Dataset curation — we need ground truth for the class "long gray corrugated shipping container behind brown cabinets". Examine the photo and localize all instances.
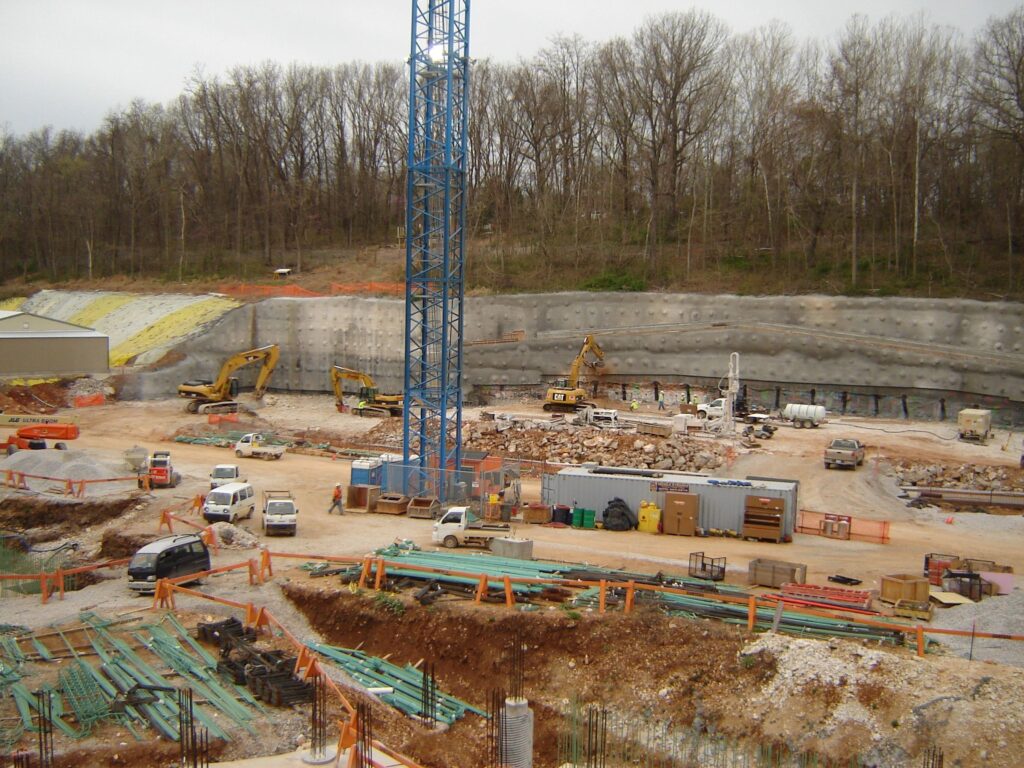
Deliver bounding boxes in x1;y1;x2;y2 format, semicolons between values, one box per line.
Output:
541;467;800;541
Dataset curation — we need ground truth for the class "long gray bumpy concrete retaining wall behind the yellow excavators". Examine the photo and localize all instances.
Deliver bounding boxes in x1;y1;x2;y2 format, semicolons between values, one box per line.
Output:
126;293;1024;421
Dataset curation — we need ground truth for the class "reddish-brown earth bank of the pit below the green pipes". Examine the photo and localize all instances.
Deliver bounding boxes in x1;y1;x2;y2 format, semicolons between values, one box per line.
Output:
284;583;798;768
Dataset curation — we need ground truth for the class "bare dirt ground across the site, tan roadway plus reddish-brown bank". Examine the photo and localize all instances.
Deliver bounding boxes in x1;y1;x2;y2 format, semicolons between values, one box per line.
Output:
0;394;1024;767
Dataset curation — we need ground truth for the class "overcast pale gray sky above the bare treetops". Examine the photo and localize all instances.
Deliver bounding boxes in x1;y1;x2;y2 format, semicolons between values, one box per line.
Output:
0;0;1020;134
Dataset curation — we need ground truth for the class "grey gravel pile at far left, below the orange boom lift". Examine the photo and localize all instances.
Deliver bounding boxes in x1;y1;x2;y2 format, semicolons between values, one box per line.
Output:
0;449;138;498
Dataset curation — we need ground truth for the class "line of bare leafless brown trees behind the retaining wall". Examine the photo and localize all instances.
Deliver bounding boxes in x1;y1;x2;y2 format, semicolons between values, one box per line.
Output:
0;7;1024;296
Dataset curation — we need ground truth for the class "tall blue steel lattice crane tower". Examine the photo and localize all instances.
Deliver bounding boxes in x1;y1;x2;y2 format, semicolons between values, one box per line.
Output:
402;0;469;502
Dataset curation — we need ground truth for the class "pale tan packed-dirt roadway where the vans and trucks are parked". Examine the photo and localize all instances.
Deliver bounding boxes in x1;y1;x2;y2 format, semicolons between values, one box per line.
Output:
54;395;1024;586
